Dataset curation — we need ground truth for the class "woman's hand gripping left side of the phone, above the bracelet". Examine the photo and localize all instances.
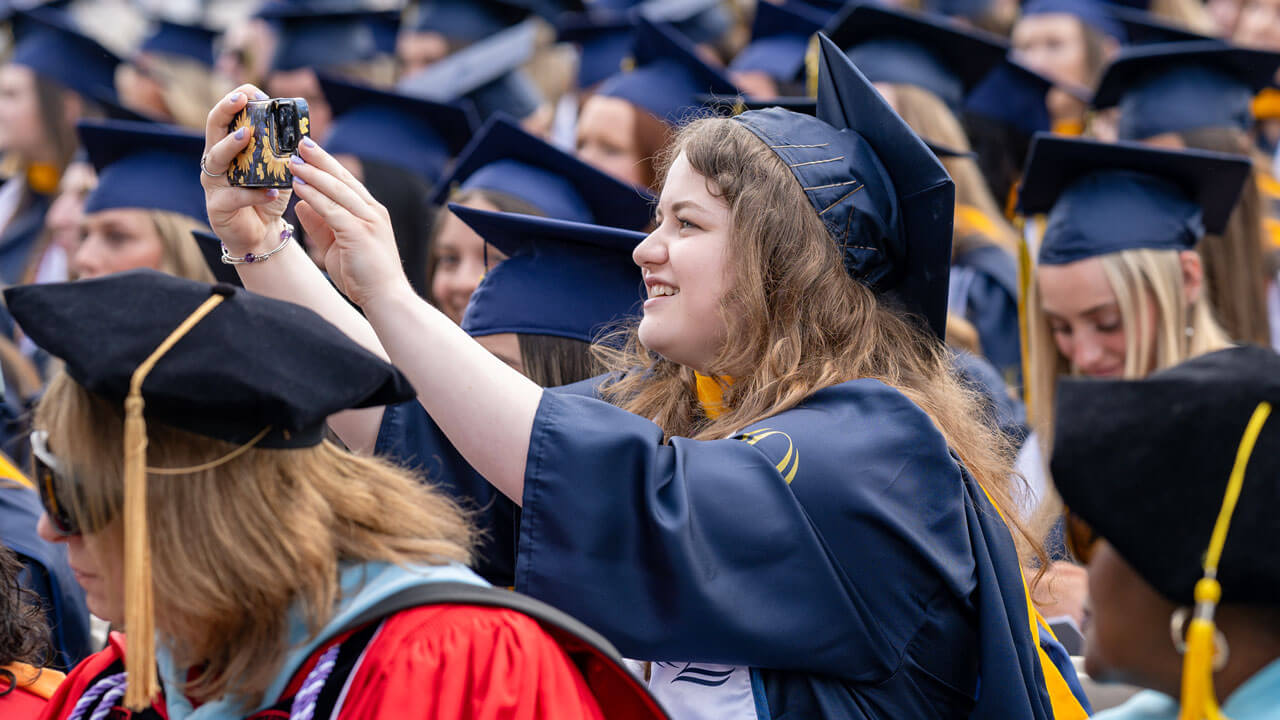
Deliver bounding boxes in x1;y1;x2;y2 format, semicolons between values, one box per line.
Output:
200;85;291;255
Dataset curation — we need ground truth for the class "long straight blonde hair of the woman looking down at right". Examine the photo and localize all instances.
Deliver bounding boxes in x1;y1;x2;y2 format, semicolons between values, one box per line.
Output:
1027;250;1230;537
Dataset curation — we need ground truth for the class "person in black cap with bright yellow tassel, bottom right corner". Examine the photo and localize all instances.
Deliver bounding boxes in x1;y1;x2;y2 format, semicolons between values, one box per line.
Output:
1052;347;1280;720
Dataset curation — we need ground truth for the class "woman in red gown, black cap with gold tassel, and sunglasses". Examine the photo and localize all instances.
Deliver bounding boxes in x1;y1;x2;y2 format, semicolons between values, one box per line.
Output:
20;270;662;720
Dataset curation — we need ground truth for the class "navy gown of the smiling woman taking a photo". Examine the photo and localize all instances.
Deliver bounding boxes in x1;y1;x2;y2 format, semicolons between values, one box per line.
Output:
516;379;1052;719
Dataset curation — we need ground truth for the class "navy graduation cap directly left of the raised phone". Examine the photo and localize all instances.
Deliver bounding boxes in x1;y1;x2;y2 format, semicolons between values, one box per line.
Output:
76;120;207;223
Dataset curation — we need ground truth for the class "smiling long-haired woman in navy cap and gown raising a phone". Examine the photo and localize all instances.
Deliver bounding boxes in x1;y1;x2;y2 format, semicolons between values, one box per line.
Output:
209;37;1085;720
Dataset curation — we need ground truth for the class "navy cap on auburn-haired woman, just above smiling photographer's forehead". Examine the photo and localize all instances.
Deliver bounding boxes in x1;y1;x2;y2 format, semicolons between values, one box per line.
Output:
596;18;737;124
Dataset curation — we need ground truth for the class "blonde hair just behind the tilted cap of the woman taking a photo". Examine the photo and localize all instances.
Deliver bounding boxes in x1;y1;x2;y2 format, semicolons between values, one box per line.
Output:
890;85;1019;256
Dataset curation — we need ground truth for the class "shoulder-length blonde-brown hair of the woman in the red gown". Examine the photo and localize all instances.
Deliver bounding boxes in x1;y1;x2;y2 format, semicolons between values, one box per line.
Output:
33;373;474;706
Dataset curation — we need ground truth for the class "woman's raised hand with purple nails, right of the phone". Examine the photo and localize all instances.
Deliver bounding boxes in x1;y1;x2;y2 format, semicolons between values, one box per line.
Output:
291;138;412;307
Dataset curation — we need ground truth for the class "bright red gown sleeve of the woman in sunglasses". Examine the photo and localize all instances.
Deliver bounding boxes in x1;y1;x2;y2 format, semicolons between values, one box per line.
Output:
339;605;603;720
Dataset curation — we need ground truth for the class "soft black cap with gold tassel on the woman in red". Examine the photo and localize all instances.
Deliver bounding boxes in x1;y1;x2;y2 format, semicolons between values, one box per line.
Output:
4;269;415;708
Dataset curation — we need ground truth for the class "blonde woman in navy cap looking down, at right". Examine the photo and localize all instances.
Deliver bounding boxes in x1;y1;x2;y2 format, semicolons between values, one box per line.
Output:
1018;135;1251;571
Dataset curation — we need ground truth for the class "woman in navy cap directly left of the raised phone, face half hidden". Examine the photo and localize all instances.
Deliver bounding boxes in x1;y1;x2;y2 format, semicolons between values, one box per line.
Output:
70;120;212;281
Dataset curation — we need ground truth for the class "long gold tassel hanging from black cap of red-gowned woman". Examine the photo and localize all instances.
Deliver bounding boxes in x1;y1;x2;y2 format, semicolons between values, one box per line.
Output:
124;295;225;712
